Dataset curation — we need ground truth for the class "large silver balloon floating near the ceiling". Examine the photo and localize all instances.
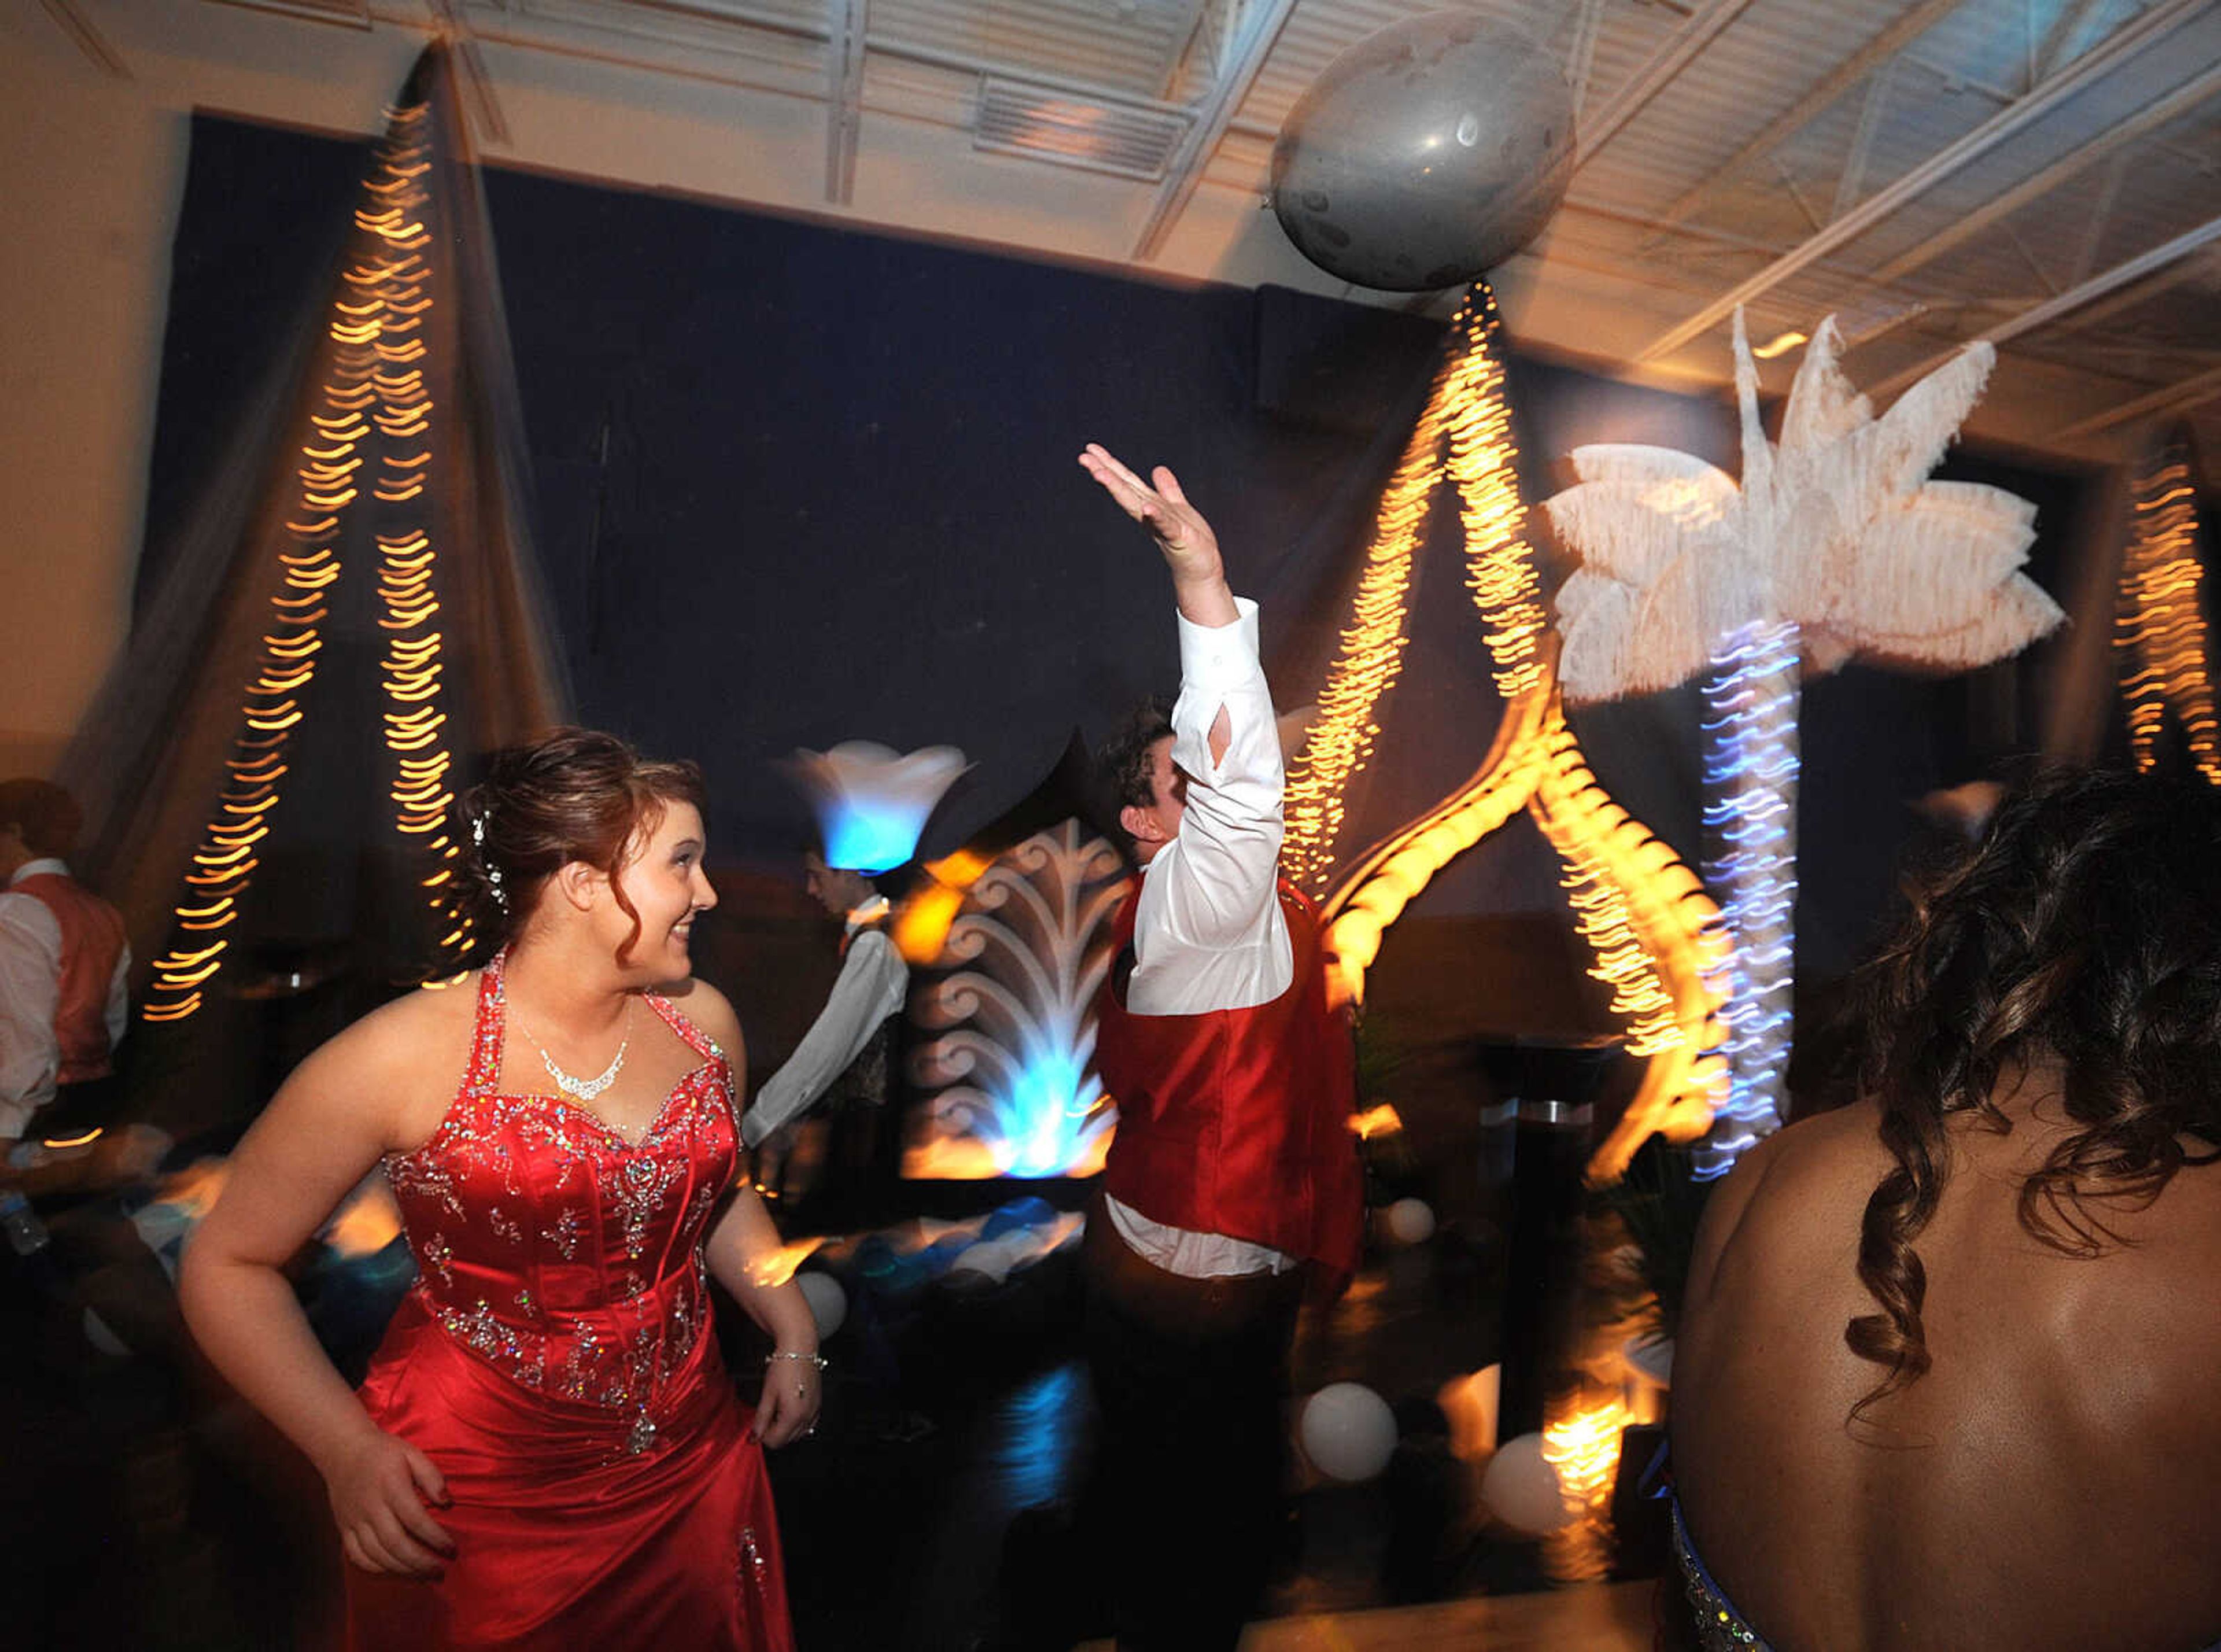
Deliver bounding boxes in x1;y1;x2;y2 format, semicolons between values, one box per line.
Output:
1272;11;1573;293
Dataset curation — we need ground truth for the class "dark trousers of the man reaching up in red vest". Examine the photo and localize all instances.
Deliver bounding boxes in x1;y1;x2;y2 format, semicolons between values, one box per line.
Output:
1084;1201;1301;1652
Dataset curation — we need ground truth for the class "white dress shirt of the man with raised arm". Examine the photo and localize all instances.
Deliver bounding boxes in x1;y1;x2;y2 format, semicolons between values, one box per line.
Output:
1104;598;1295;1279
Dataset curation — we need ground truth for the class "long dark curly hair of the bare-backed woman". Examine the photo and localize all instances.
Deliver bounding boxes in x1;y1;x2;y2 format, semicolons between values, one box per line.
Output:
1843;770;2221;1421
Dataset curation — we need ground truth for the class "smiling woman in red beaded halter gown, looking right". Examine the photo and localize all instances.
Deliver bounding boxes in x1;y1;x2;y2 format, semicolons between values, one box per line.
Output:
180;731;820;1652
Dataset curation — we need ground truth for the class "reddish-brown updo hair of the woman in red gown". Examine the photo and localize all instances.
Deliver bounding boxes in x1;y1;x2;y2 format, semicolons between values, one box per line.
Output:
455;728;706;964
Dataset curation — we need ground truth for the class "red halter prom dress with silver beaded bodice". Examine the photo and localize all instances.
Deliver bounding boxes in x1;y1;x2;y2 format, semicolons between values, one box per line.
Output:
349;959;793;1652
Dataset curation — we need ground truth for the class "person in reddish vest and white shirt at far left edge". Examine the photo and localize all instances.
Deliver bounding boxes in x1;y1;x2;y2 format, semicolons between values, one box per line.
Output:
0;779;131;1155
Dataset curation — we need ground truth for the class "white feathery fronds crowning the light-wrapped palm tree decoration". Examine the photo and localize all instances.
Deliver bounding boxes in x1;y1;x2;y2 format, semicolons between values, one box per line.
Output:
1544;315;2063;702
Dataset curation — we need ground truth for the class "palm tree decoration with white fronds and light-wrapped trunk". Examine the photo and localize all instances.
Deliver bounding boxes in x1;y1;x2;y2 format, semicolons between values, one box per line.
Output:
1544;311;2063;1175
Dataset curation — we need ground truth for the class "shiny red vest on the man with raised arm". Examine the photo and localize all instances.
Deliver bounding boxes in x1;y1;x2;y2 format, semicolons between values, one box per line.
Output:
1095;879;1364;1286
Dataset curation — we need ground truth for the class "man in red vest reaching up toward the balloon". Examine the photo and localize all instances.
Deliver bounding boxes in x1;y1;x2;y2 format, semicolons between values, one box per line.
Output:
1079;447;1364;1647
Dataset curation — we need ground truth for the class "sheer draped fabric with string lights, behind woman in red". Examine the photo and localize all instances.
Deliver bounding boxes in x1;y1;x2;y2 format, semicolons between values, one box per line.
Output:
56;45;569;990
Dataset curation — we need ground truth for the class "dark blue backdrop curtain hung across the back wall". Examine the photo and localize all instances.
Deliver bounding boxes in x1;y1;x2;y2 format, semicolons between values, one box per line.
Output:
142;116;2081;999
